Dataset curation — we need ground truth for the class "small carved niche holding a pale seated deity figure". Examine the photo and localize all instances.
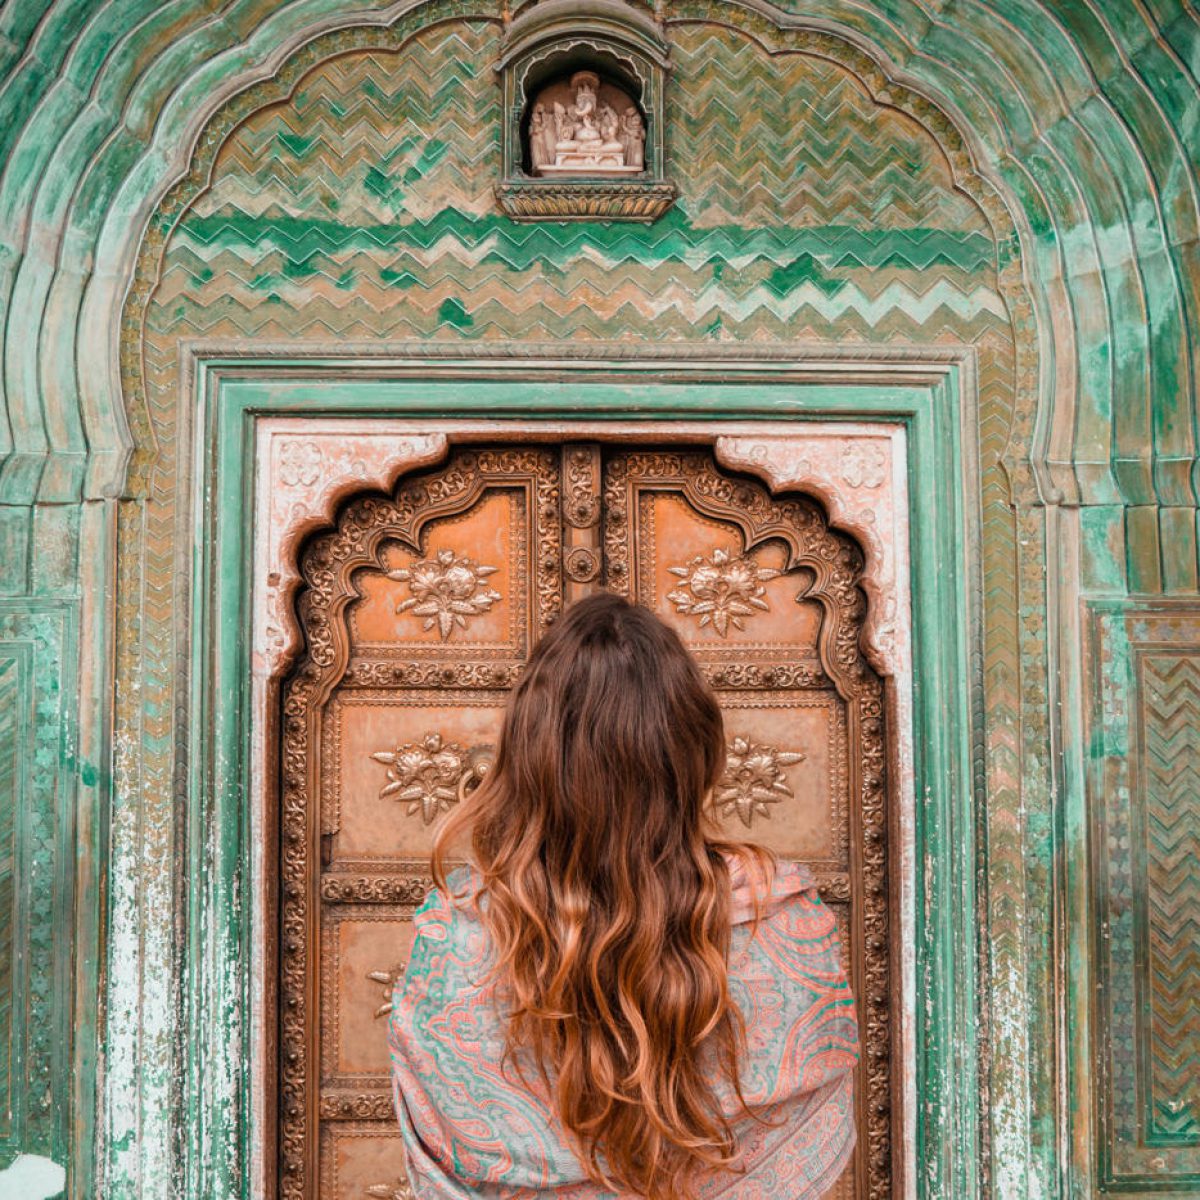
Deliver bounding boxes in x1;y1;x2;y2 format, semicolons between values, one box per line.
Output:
496;0;676;222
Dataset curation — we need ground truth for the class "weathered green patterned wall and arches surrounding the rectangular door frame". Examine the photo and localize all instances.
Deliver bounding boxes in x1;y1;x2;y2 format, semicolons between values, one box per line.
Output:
0;0;1200;1200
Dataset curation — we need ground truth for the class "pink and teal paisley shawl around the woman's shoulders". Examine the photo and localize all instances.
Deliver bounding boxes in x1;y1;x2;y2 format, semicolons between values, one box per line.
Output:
389;864;858;1200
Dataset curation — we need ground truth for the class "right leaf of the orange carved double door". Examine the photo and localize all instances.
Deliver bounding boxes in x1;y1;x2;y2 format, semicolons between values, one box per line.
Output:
604;450;890;1196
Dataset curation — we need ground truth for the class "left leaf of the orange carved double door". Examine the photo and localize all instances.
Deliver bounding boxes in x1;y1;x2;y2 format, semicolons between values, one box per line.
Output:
278;448;563;1200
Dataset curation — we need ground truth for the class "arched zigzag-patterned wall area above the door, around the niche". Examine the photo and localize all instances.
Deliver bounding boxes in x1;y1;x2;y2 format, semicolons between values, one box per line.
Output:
146;20;1010;357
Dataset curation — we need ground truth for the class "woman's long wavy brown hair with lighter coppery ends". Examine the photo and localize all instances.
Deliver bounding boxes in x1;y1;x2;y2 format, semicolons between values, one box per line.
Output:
433;594;772;1200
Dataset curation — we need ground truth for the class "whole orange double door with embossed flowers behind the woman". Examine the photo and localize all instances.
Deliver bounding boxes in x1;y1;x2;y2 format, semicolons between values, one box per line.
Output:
278;444;892;1200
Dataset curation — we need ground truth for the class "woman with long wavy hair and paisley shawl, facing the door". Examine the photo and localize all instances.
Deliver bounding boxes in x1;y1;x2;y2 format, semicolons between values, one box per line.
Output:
390;594;858;1200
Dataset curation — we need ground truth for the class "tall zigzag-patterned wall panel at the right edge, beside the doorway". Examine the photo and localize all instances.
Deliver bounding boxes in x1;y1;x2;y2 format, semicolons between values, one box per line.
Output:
1090;601;1200;1195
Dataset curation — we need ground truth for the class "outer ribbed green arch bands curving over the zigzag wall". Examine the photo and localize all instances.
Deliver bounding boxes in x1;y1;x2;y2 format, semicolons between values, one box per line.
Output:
0;0;1200;530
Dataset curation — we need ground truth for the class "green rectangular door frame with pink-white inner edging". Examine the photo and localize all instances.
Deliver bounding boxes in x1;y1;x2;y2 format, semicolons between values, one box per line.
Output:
185;343;986;1198
